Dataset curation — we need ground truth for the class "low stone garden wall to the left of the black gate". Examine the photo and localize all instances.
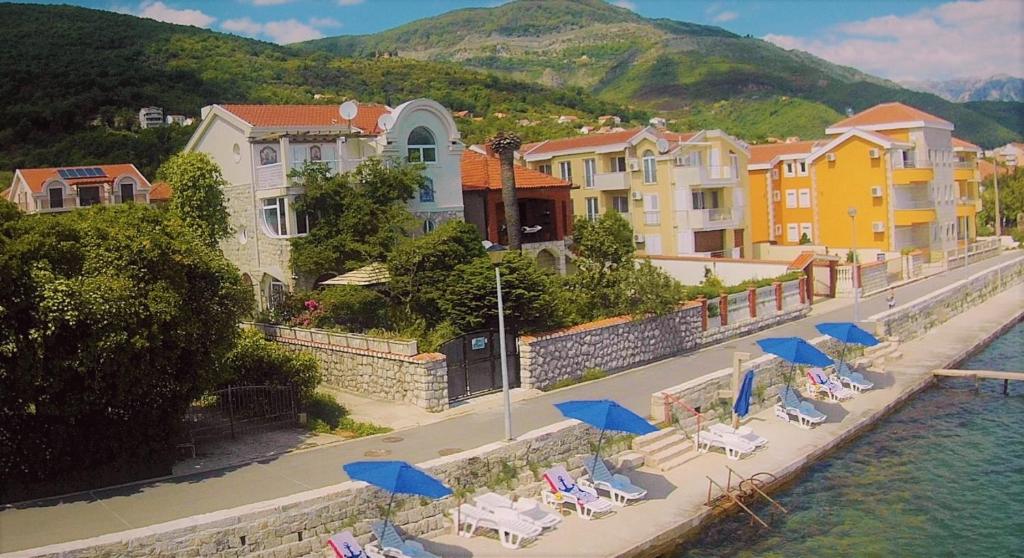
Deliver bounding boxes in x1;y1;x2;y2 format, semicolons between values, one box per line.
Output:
246;324;449;412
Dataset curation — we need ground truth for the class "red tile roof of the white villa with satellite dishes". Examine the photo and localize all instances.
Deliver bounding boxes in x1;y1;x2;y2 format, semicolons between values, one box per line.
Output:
221;103;391;135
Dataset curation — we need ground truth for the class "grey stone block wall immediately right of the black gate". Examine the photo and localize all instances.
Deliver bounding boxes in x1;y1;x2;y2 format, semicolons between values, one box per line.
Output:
519;303;700;389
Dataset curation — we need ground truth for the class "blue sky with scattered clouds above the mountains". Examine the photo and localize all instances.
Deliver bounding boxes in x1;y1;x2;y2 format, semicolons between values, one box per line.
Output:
16;0;1024;80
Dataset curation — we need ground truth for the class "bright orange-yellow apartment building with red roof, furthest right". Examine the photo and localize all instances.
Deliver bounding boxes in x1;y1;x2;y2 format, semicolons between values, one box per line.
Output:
748;102;979;252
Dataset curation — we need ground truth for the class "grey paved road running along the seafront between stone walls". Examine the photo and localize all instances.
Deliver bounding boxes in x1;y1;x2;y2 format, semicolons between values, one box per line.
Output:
0;251;1021;552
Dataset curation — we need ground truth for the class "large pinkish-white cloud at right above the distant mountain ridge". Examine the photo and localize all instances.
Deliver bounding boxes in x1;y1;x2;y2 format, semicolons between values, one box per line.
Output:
764;0;1024;80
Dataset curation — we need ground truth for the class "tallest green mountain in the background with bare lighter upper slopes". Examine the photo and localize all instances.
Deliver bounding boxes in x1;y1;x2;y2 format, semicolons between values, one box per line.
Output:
295;0;1024;146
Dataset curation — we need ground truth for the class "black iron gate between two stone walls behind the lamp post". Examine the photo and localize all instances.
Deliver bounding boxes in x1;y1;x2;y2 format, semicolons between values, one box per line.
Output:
441;330;519;401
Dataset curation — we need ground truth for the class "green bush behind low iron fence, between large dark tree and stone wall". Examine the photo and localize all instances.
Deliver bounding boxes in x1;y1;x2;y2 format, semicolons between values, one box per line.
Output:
223;330;321;403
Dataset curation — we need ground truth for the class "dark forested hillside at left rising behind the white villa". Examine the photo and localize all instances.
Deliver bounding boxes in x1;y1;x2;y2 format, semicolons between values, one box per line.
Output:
0;4;648;176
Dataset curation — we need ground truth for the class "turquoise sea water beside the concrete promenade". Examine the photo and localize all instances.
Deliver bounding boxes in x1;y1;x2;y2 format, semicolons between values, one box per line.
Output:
674;323;1024;558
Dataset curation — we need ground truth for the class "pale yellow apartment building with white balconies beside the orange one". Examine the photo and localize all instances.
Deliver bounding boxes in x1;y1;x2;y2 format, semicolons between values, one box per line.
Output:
520;127;751;257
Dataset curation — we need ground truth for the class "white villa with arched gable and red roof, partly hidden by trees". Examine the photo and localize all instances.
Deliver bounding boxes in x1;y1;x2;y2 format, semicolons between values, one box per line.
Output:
185;99;464;307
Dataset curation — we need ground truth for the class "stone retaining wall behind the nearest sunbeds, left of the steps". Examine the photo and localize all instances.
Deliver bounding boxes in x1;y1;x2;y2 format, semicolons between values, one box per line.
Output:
25;421;631;558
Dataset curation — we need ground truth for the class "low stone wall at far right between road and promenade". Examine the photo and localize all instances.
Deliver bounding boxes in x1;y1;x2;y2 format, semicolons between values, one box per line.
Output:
868;251;1024;341
